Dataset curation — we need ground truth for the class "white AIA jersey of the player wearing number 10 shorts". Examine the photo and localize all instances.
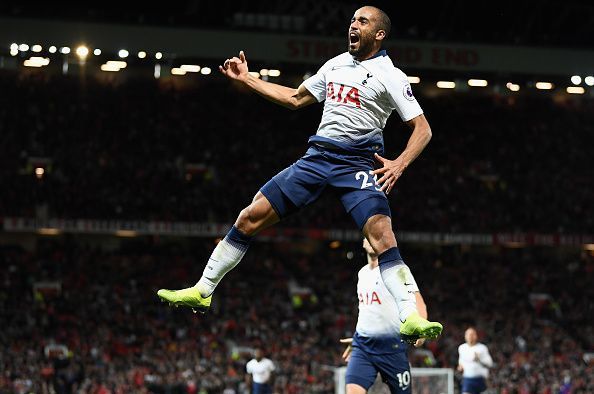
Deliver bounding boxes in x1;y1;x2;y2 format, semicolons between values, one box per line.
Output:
357;264;419;337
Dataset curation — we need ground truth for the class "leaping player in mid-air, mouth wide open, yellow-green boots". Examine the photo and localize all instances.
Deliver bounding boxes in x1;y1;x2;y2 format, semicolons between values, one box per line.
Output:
158;6;442;342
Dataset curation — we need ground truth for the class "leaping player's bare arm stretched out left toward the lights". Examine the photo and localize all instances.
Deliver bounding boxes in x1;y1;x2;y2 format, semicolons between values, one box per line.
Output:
219;51;317;109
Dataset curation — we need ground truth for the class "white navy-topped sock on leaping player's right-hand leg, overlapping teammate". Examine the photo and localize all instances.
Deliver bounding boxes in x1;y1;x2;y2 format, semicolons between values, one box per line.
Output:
378;247;419;322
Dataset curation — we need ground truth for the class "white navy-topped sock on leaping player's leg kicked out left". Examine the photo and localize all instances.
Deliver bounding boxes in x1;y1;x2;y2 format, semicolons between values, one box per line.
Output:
196;226;252;297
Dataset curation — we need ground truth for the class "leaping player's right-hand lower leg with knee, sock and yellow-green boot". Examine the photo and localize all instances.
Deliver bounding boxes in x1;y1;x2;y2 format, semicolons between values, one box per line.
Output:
363;214;443;343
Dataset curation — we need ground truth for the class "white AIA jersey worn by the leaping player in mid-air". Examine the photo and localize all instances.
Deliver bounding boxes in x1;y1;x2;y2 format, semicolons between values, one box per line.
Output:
303;50;423;144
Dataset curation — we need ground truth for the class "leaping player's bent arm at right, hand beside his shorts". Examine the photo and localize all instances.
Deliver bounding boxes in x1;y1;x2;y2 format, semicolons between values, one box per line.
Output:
373;114;431;194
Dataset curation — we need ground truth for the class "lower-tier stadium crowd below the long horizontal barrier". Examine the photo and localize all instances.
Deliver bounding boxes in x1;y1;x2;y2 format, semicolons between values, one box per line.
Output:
0;237;594;394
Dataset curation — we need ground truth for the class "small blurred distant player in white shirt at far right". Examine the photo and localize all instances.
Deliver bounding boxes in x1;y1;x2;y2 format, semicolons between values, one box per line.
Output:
458;327;493;394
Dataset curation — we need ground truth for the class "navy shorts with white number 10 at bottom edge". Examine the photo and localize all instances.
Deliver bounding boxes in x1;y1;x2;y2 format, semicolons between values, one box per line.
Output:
346;346;412;394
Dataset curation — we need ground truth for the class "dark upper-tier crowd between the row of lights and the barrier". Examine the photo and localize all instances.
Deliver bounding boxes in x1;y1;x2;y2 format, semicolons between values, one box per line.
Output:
0;72;594;234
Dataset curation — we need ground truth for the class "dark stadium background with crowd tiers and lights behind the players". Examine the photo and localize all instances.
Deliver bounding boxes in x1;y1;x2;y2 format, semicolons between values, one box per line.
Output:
0;0;594;394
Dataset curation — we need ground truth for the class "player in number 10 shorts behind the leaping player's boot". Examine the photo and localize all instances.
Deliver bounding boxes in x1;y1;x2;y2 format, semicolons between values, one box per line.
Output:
340;240;427;394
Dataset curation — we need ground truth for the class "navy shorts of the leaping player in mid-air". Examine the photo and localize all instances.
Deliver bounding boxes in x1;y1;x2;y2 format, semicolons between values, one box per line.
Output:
260;145;391;229
